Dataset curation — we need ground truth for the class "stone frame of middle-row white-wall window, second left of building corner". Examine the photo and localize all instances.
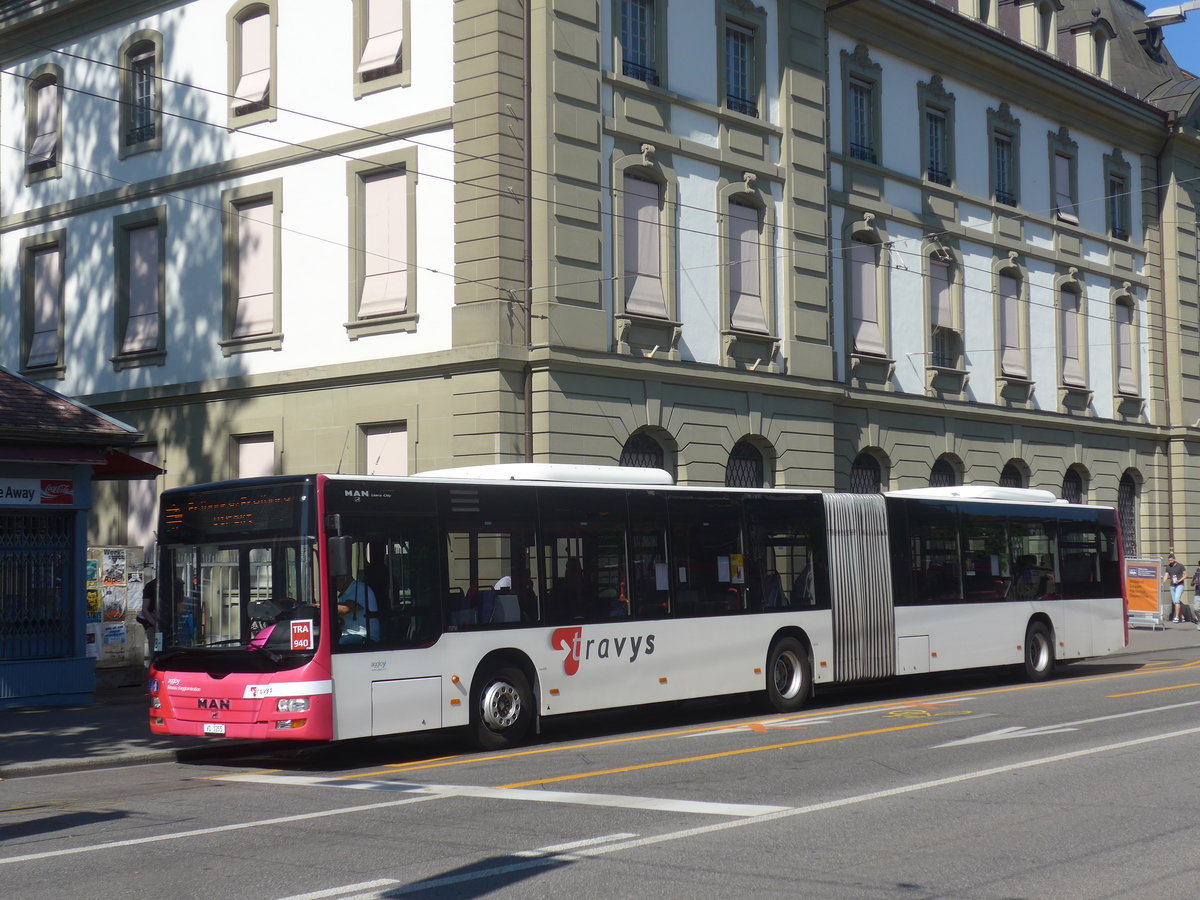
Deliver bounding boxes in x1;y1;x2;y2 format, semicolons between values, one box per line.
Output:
218;179;283;356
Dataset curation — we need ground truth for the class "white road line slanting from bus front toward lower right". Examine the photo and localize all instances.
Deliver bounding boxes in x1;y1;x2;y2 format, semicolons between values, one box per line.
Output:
216;773;791;818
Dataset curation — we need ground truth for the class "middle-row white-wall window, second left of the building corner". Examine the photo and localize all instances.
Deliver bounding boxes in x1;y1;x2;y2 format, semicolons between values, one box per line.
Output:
221;181;283;356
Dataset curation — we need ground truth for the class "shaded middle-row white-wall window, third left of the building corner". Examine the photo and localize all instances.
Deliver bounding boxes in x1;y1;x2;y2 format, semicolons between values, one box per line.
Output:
113;208;167;368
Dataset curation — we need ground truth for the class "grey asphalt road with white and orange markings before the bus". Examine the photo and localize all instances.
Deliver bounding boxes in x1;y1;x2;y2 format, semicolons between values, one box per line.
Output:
0;648;1200;900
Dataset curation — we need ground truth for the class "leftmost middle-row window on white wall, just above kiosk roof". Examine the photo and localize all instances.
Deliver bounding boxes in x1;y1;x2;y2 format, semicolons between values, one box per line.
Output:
20;232;66;378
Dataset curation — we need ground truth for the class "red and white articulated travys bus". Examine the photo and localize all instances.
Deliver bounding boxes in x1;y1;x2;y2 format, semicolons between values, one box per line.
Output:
150;463;1128;749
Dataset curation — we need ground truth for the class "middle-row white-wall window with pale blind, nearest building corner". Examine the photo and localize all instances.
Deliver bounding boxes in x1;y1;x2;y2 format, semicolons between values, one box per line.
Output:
347;151;416;340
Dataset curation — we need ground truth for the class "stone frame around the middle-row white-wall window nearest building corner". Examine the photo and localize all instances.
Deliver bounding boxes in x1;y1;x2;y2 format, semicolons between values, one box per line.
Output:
346;146;419;341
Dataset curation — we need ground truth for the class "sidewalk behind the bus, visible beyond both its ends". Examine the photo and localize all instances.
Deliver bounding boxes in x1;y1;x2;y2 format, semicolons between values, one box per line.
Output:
0;624;1200;780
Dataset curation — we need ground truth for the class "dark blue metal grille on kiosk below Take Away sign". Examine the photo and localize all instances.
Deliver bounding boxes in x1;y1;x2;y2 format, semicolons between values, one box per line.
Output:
0;512;74;660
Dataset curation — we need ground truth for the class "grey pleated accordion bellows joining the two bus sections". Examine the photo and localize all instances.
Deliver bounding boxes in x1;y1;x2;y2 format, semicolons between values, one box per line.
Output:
824;493;896;682
